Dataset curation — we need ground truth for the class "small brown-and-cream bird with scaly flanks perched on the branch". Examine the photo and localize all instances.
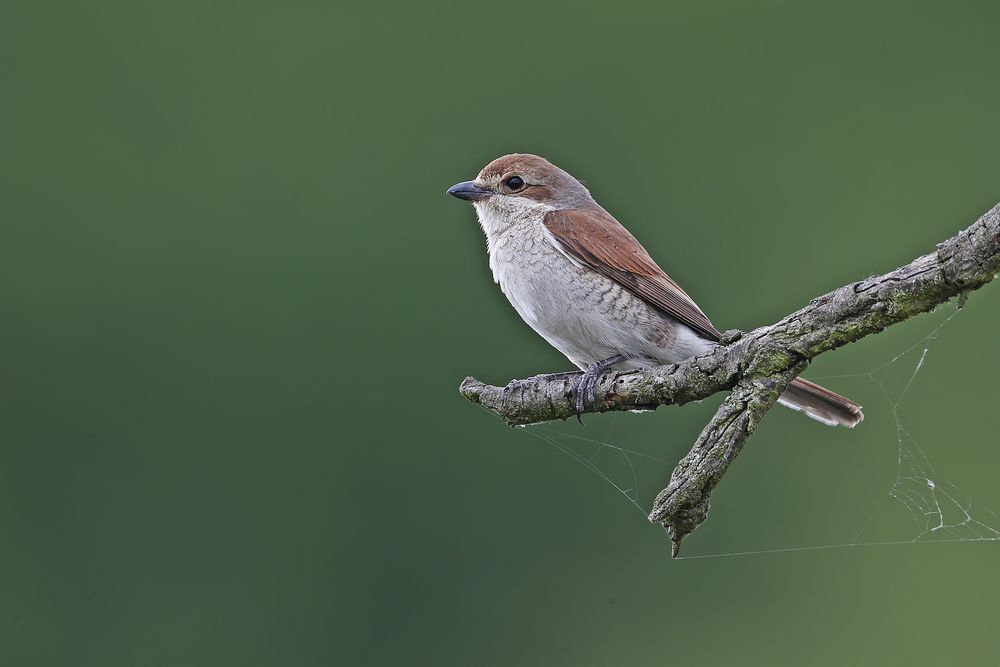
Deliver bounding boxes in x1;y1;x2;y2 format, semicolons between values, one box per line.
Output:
447;153;864;428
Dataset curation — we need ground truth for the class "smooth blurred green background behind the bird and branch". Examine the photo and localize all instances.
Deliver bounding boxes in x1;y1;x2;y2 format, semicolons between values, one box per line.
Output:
0;0;1000;666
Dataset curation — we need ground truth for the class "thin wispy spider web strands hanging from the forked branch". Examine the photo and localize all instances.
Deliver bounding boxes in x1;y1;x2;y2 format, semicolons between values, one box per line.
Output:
504;310;1000;560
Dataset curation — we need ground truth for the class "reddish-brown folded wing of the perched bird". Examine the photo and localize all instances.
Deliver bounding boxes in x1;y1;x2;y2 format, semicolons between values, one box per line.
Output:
545;208;720;340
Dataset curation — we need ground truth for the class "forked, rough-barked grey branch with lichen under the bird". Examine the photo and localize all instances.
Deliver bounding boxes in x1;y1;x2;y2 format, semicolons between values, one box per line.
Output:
460;204;1000;556
